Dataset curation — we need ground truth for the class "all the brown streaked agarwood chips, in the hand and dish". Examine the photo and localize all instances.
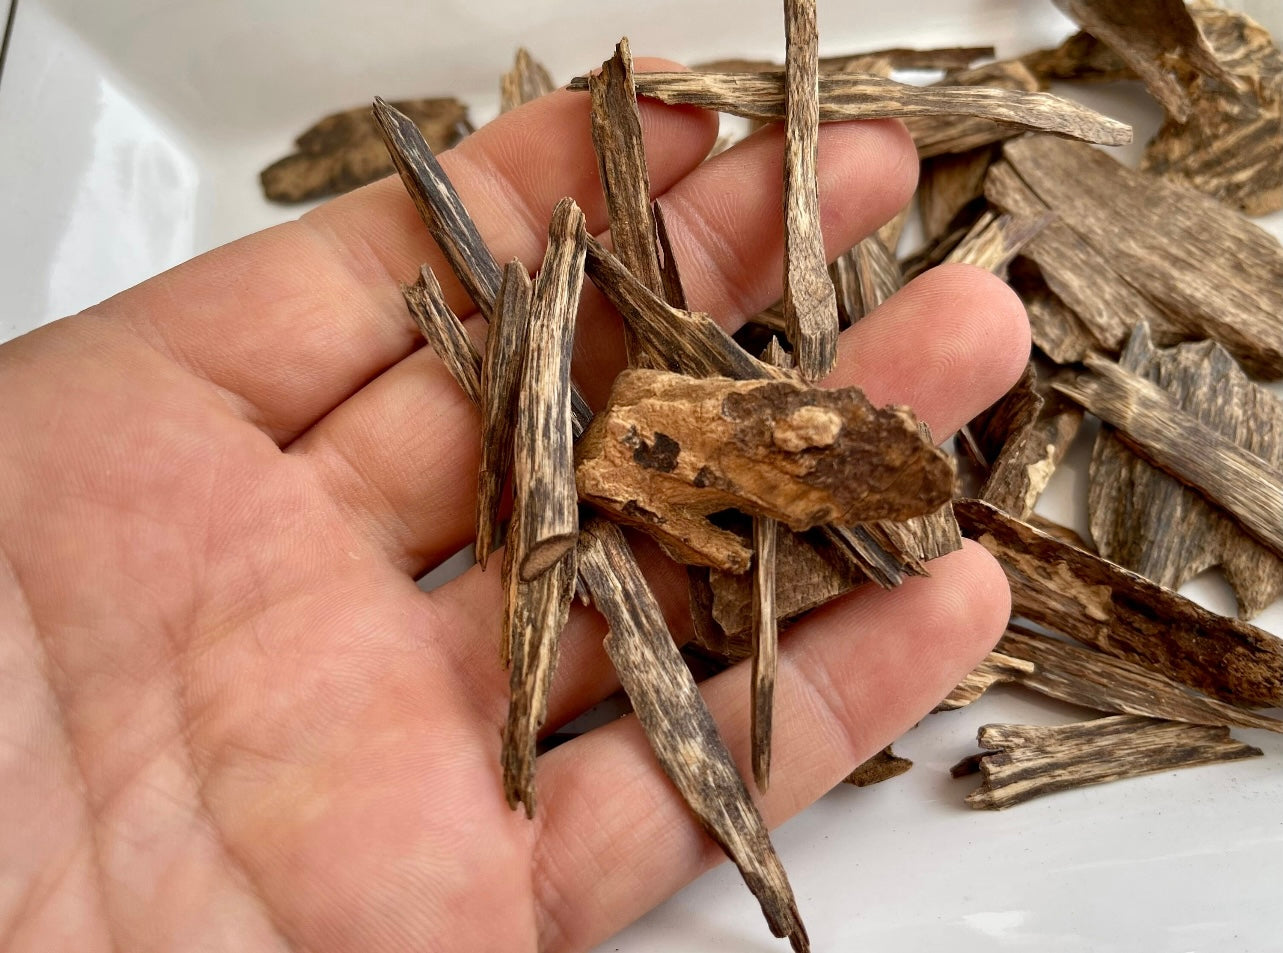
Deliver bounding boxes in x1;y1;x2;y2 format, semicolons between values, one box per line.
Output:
263;0;1283;950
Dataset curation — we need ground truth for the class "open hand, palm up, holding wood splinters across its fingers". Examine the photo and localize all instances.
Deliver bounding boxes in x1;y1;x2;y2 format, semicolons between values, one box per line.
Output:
0;62;1029;953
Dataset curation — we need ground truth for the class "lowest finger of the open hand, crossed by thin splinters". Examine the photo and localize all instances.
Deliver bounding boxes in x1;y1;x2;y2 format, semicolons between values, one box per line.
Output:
534;544;1010;949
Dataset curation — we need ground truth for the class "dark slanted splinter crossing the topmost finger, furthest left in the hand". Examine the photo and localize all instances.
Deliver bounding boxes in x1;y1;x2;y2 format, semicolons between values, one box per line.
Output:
375;99;593;436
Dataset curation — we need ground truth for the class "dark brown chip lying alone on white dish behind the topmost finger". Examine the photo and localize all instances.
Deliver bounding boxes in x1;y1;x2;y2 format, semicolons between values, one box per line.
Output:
259;99;472;203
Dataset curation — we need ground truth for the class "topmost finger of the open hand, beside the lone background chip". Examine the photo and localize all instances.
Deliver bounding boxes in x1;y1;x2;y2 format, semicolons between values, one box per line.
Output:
99;60;717;443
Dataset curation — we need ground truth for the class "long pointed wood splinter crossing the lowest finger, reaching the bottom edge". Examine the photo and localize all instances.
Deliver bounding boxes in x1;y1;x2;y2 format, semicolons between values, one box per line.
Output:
579;518;810;953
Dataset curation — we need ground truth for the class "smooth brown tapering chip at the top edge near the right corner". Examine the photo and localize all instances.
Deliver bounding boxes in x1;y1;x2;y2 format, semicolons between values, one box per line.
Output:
1055;0;1234;122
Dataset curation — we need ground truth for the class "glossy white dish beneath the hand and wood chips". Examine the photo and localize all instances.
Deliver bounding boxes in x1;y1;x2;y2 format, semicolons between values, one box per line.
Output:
0;0;1283;953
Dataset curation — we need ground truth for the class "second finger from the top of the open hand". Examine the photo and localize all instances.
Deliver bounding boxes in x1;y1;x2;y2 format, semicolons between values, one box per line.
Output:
291;117;923;572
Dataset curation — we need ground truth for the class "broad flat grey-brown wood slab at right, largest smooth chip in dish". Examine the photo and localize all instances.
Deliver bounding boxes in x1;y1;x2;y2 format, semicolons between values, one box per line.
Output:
989;136;1283;378
